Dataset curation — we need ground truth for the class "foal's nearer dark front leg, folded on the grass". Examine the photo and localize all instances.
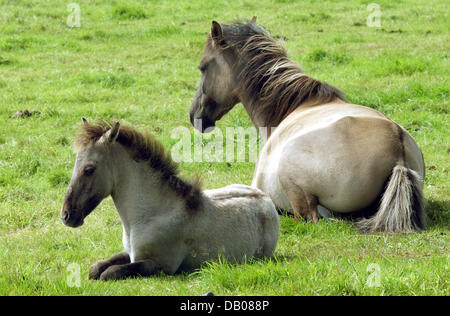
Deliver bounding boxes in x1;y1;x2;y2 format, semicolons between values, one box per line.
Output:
100;259;161;281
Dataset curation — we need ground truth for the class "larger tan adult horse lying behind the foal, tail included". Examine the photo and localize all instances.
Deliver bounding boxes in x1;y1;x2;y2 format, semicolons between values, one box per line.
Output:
190;19;425;232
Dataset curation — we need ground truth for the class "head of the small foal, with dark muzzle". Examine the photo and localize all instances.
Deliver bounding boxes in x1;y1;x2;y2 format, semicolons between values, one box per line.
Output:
61;119;120;227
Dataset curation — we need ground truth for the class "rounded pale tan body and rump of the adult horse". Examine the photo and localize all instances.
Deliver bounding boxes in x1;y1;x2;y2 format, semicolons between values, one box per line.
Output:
255;104;423;213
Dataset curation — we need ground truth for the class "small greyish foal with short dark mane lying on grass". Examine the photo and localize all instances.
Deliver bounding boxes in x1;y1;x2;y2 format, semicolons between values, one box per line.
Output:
61;119;280;280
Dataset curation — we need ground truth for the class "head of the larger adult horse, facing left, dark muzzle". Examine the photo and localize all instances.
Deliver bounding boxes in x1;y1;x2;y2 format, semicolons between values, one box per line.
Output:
189;21;240;132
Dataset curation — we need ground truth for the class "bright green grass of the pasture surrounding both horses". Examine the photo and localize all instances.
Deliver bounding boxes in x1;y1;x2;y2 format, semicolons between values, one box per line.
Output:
0;0;450;295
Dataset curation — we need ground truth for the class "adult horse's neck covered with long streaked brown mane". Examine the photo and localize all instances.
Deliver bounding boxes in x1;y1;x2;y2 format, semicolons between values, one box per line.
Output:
222;21;345;126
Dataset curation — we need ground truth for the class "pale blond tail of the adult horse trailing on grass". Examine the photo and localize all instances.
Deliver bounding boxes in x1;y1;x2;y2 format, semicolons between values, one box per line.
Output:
357;163;425;233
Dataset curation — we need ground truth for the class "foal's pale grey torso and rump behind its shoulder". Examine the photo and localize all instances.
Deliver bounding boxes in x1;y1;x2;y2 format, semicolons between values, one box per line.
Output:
178;184;280;270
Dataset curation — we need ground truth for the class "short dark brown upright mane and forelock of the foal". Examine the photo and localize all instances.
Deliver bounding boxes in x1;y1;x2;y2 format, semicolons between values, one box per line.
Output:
75;121;201;210
